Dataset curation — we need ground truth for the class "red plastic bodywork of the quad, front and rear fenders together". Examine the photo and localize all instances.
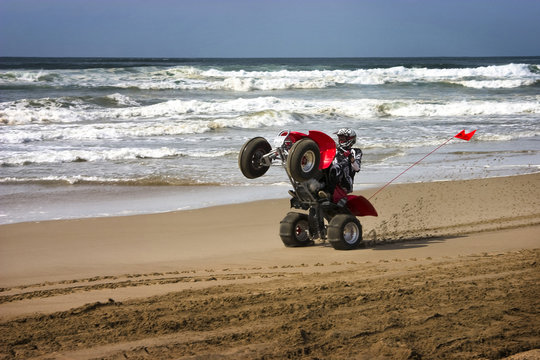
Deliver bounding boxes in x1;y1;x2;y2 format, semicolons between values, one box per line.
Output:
282;130;378;216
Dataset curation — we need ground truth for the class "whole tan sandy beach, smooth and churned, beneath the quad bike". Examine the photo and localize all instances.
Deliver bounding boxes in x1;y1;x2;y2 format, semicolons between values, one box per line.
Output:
0;174;540;359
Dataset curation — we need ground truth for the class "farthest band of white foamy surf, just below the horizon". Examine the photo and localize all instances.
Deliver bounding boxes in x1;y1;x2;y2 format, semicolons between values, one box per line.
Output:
0;64;540;92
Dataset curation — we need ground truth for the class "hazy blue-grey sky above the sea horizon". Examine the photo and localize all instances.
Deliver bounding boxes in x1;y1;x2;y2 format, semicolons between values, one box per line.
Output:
0;0;540;58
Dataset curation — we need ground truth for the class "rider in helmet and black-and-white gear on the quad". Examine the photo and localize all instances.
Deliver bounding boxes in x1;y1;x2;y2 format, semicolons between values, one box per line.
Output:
319;128;362;206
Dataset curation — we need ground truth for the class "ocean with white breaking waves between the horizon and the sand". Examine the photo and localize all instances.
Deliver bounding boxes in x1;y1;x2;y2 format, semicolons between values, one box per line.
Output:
0;57;540;224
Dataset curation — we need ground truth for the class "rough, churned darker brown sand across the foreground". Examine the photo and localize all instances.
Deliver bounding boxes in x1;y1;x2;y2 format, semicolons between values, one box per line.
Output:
0;250;540;359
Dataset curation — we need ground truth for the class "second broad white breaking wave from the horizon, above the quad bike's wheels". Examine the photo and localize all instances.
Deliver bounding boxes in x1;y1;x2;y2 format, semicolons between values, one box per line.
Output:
0;96;540;130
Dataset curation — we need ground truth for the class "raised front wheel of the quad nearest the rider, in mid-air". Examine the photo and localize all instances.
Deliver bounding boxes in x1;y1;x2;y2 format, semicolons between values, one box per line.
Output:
287;138;321;182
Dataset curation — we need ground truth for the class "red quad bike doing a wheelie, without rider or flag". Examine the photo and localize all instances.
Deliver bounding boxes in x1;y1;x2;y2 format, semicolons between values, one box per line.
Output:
238;130;377;250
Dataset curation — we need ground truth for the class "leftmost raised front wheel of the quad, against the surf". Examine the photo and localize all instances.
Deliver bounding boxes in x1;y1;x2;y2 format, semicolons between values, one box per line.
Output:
238;137;272;179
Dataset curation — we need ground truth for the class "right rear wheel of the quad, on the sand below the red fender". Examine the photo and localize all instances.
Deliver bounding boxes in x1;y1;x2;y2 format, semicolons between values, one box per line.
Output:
328;214;362;250
